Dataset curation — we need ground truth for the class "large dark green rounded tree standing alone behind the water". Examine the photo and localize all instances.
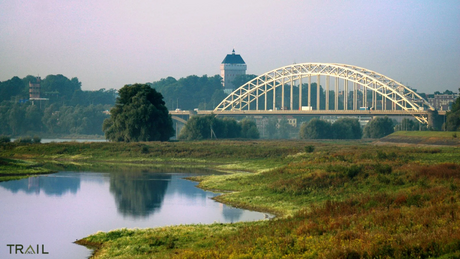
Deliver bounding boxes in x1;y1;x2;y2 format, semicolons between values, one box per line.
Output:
103;84;174;142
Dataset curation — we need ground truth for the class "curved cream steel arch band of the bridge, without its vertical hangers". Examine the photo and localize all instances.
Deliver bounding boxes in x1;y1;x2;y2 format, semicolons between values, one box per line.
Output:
214;63;434;124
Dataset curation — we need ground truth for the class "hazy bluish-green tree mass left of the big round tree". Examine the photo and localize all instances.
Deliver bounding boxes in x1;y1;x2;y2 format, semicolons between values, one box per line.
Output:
0;75;116;136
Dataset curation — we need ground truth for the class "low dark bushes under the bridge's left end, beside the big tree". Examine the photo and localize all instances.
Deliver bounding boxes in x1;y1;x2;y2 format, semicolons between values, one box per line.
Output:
179;114;259;140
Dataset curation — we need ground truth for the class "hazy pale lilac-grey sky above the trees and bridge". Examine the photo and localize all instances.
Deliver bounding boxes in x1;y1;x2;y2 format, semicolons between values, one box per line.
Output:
0;0;460;93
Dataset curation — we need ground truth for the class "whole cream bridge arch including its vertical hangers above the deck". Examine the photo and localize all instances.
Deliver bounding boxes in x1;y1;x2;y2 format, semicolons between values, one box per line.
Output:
214;63;434;124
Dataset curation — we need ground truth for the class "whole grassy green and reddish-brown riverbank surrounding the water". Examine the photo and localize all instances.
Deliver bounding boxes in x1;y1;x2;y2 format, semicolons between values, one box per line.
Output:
0;138;460;258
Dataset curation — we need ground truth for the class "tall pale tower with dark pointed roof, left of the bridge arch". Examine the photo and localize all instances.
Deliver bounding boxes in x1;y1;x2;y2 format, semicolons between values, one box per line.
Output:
220;49;247;94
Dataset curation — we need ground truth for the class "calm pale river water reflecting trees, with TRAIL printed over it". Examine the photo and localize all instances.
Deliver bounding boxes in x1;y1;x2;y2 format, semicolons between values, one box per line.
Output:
0;172;265;259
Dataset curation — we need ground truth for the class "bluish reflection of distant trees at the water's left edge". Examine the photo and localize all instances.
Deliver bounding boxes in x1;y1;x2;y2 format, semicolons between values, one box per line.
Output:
1;175;80;196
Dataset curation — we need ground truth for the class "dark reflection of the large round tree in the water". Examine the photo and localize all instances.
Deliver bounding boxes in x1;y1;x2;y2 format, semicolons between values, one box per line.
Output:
110;173;171;218
